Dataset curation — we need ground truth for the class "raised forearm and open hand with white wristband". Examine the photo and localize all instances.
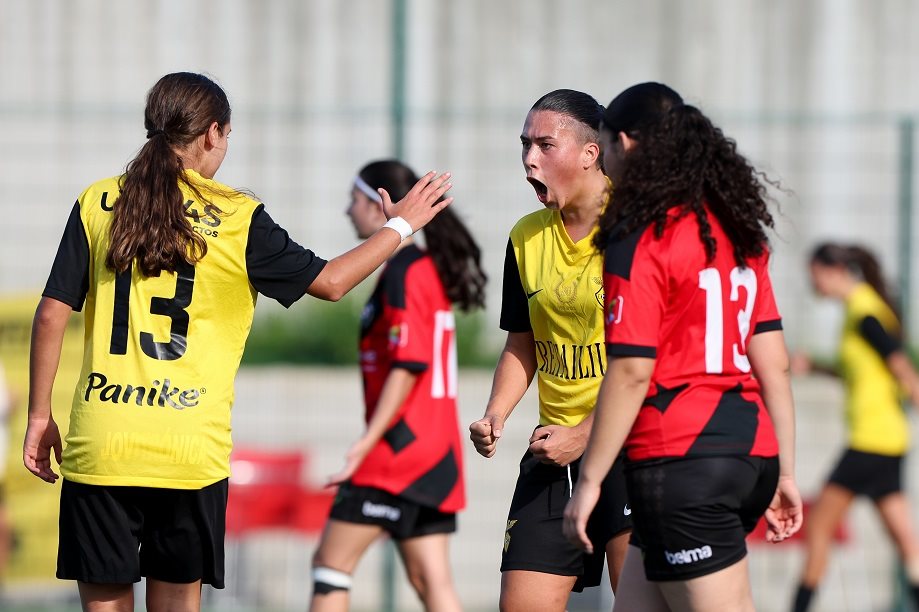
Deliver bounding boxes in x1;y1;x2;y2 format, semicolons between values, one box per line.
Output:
306;172;453;302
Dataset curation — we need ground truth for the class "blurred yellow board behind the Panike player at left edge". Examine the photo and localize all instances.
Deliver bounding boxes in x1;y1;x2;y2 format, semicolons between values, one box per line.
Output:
0;291;83;586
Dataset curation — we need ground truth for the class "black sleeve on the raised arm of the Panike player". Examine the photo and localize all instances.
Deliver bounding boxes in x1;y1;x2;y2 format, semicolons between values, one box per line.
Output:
246;204;326;308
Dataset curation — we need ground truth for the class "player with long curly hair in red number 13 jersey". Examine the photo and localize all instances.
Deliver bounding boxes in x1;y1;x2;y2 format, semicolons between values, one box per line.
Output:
565;83;802;610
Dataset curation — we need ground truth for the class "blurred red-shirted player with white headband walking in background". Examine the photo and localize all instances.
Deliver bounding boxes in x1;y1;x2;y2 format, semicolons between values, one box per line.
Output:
310;160;486;612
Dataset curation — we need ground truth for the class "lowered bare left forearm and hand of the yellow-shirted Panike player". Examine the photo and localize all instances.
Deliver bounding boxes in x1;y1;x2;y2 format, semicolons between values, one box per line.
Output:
22;297;72;483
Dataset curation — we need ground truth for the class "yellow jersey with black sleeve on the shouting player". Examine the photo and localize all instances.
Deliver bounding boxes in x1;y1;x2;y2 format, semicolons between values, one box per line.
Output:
501;209;606;427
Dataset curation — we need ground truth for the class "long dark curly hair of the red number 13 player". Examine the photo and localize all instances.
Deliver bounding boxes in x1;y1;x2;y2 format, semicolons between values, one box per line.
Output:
594;83;778;266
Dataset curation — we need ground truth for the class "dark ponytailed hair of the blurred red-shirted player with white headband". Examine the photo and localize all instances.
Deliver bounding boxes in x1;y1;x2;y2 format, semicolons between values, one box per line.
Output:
358;159;488;312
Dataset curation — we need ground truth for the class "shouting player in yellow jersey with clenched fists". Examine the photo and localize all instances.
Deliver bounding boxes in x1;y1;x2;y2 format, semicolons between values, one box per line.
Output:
469;89;631;612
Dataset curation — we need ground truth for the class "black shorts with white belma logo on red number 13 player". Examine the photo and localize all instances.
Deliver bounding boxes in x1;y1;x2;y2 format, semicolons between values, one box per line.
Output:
625;457;779;581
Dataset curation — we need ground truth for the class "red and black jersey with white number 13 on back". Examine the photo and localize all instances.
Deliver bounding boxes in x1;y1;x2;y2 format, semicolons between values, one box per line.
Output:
604;207;782;461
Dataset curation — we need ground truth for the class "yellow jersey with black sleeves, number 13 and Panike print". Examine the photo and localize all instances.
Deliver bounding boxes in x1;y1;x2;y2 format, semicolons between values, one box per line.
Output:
43;171;325;489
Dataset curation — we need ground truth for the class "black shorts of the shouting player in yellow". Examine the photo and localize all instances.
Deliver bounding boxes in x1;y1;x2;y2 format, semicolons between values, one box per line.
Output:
501;450;632;591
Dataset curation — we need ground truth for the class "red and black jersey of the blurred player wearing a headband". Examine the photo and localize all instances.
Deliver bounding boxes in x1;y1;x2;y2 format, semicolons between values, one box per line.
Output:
352;245;466;512
